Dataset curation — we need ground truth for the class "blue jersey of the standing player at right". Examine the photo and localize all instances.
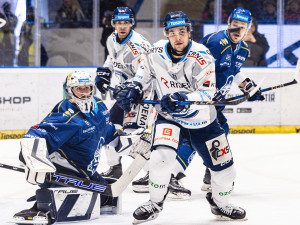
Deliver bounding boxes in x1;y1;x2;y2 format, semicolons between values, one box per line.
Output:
200;30;249;98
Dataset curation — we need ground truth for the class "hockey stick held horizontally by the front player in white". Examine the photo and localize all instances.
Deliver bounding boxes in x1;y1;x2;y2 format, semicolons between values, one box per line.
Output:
105;79;264;106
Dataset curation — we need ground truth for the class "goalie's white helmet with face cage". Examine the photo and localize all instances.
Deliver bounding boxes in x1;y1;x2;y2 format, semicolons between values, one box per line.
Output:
64;71;96;113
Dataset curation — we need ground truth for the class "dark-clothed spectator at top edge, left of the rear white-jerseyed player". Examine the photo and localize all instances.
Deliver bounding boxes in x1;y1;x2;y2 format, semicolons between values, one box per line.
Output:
56;0;85;28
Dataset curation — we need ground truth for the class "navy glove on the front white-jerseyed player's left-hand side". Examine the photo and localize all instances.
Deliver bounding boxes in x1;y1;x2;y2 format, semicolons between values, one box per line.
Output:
114;81;143;112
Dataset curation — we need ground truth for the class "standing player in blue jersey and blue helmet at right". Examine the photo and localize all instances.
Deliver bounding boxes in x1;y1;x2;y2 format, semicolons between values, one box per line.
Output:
200;7;265;191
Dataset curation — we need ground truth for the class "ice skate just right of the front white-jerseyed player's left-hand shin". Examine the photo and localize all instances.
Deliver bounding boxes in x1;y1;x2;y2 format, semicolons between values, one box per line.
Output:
167;173;191;200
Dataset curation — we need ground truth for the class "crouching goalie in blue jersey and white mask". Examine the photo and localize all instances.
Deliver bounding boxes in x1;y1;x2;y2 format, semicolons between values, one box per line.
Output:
14;71;118;224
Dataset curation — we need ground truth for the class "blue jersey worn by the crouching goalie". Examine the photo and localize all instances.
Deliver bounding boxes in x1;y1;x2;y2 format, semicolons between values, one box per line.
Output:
24;97;117;177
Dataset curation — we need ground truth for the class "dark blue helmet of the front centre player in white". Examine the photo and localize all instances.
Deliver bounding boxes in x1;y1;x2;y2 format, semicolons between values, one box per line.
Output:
164;11;192;33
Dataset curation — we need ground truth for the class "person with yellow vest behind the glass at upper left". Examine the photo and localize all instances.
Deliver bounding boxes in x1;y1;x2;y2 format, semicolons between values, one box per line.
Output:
18;7;48;66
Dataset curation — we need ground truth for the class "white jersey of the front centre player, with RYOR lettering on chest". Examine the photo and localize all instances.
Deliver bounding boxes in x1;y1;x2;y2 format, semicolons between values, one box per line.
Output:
133;40;216;129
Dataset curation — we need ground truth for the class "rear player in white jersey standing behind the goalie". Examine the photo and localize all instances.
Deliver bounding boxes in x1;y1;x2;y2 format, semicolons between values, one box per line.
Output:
95;7;151;179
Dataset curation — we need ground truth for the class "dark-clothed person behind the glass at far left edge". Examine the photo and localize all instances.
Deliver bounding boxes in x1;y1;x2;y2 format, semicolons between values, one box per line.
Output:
0;2;18;66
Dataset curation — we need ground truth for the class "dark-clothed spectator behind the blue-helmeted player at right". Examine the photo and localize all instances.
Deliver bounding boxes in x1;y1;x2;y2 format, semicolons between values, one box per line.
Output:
244;18;270;66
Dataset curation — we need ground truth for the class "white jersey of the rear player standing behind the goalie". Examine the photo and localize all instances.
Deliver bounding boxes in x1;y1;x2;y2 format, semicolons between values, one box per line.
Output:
103;30;150;83
